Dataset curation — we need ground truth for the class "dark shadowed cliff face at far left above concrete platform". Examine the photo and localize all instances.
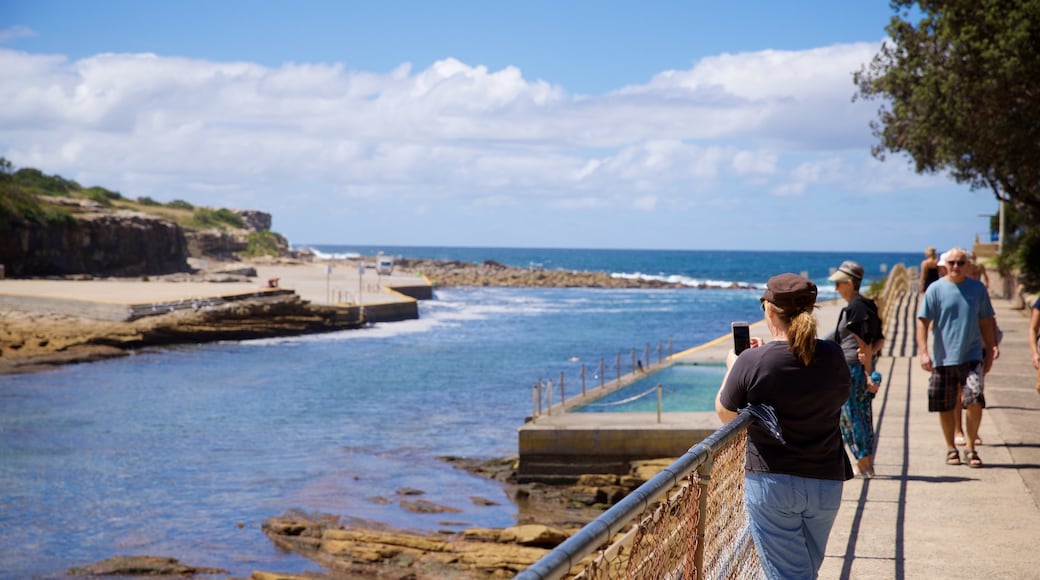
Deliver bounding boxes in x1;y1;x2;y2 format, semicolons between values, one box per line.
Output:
0;211;188;276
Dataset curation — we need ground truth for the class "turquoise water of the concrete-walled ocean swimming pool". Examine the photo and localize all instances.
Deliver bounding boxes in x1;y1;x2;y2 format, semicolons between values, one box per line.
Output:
572;363;726;413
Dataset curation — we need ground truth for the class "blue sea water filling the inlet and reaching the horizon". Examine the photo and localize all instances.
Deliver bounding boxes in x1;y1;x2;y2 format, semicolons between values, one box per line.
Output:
0;244;921;578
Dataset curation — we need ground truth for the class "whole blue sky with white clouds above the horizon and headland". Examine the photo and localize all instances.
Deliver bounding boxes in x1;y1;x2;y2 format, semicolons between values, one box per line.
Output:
0;0;997;252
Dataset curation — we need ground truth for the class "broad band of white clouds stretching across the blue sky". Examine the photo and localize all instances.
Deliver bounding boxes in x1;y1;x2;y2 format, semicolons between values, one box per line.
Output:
0;39;981;251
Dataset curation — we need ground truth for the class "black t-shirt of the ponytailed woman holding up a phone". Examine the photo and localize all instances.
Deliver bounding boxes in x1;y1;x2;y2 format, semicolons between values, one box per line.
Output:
720;340;853;481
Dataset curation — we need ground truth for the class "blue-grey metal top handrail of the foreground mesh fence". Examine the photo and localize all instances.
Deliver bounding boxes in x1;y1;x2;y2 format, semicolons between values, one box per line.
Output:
516;413;753;580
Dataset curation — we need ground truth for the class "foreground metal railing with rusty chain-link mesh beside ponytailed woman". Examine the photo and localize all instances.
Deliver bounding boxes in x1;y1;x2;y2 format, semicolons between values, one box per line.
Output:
516;413;761;580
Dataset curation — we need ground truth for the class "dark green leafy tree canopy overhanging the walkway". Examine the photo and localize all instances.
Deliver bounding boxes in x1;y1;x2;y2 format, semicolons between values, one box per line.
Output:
854;0;1040;223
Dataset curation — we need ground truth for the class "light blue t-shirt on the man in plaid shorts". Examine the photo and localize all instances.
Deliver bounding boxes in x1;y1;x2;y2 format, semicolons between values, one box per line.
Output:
917;278;994;367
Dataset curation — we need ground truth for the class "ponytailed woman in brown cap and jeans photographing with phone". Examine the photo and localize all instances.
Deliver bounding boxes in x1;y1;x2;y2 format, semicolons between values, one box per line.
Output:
716;273;853;579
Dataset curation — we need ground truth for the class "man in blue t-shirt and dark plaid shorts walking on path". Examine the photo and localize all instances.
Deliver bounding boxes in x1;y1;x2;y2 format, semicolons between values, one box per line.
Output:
917;247;999;468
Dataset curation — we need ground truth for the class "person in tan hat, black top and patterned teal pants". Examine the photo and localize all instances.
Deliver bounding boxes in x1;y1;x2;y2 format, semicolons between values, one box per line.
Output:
829;260;885;478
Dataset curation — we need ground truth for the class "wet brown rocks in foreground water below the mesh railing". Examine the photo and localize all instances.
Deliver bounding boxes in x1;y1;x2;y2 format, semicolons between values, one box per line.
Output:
67;457;673;580
